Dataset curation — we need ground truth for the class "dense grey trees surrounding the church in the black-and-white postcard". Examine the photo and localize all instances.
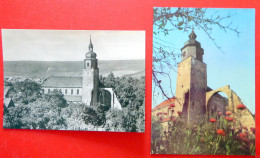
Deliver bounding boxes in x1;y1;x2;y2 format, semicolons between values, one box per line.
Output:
4;73;144;132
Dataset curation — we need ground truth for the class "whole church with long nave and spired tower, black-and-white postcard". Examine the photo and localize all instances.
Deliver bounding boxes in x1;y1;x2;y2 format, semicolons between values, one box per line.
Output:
42;38;121;109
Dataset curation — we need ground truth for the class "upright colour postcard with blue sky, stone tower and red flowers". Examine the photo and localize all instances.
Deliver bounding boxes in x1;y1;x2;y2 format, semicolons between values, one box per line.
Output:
151;7;255;155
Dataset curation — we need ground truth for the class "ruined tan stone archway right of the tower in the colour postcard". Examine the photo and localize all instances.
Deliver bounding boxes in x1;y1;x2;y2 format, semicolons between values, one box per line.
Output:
206;85;255;128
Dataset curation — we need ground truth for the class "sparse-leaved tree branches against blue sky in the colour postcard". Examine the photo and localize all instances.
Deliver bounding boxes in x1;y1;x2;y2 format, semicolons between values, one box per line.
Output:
152;8;239;103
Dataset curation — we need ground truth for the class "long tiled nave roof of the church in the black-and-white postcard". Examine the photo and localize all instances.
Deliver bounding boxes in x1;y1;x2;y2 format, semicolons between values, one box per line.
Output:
42;76;82;88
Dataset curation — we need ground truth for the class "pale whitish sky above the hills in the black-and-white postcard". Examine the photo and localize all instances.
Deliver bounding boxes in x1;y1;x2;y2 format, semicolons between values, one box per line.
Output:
2;29;145;61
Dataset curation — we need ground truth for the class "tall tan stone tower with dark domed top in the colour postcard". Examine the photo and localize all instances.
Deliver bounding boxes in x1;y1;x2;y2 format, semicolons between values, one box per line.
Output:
175;30;207;123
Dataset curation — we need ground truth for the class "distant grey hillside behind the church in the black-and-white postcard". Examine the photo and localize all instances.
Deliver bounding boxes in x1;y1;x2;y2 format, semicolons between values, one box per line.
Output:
4;60;145;77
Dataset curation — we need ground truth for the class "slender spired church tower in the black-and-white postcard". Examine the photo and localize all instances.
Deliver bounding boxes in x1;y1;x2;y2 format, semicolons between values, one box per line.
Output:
82;37;99;106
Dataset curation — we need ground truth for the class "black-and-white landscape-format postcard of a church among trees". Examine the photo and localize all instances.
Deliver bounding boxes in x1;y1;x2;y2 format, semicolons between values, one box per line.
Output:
2;29;145;132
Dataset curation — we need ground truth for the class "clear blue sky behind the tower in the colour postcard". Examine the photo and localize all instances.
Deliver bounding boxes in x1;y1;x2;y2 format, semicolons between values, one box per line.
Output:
152;8;255;113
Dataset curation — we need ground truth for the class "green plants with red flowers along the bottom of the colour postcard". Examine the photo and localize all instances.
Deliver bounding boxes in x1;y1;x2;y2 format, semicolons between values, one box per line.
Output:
152;111;255;155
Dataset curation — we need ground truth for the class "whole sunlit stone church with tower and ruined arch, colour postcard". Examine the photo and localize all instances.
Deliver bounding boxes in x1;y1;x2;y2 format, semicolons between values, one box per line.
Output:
152;30;255;128
